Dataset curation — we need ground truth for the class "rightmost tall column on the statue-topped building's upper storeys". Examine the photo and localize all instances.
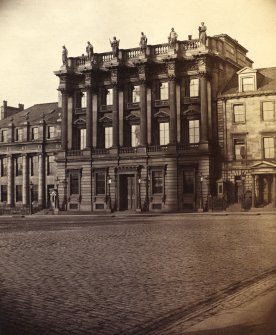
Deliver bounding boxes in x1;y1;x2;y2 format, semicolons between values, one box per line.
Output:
200;73;208;142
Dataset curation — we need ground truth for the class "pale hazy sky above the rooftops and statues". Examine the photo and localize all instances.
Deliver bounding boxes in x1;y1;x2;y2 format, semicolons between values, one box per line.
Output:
0;0;276;108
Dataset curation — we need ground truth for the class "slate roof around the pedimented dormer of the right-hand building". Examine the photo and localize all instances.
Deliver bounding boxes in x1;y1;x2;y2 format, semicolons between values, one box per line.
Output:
222;67;276;94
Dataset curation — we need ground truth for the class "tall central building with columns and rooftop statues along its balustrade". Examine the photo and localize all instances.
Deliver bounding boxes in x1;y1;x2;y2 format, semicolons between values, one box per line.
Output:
52;30;252;211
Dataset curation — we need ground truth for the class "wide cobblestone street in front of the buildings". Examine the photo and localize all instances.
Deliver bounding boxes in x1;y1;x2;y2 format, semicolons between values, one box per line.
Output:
0;215;276;335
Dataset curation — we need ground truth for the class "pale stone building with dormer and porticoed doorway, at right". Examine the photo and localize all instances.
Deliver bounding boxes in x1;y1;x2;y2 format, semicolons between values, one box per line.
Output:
218;67;276;209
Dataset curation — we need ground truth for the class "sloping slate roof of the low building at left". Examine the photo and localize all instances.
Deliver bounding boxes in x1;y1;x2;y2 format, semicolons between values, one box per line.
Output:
0;102;61;128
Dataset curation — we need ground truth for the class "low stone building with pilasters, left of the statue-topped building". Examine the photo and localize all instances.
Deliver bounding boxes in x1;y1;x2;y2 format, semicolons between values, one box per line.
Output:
0;101;61;213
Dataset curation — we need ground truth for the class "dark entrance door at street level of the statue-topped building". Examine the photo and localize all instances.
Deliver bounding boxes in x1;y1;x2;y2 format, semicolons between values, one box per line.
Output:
120;174;136;211
